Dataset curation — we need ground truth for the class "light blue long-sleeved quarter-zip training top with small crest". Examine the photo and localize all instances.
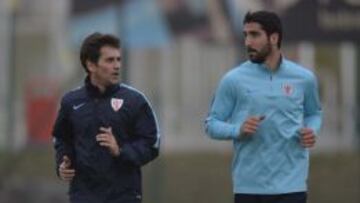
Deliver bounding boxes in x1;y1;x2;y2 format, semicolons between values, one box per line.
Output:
205;58;322;194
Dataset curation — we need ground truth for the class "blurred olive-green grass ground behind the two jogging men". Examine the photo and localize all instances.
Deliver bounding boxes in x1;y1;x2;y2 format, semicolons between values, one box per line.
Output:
0;147;360;203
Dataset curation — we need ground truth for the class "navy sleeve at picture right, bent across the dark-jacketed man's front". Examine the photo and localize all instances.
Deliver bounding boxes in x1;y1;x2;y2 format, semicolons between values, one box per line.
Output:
120;97;160;166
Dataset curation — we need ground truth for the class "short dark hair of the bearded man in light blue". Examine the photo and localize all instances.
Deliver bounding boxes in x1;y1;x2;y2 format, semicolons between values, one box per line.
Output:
243;11;283;48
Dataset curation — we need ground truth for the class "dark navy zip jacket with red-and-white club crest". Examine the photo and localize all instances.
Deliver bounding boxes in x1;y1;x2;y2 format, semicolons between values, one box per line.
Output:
53;78;160;203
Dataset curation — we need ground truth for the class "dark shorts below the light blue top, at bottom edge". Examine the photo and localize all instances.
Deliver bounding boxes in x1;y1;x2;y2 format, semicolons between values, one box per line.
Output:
235;192;307;203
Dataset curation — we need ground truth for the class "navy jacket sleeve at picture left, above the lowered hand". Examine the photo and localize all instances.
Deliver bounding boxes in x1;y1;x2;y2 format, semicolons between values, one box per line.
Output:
52;100;74;173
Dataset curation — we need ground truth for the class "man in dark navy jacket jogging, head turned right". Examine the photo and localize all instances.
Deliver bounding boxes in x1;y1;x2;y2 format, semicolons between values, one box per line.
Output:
53;33;160;203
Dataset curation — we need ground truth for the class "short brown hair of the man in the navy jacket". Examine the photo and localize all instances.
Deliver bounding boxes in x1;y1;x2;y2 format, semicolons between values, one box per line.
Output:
80;32;120;73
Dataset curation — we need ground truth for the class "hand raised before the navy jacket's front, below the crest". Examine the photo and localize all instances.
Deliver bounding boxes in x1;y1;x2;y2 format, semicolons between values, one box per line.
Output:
96;127;120;156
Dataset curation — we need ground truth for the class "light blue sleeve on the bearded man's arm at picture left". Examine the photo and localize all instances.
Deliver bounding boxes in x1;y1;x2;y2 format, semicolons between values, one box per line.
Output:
205;76;241;140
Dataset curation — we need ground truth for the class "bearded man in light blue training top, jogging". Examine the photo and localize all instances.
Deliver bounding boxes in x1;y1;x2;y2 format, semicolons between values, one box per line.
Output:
205;11;322;203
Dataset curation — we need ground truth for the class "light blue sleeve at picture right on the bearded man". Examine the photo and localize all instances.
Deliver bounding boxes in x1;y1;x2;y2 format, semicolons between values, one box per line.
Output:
304;72;322;135
